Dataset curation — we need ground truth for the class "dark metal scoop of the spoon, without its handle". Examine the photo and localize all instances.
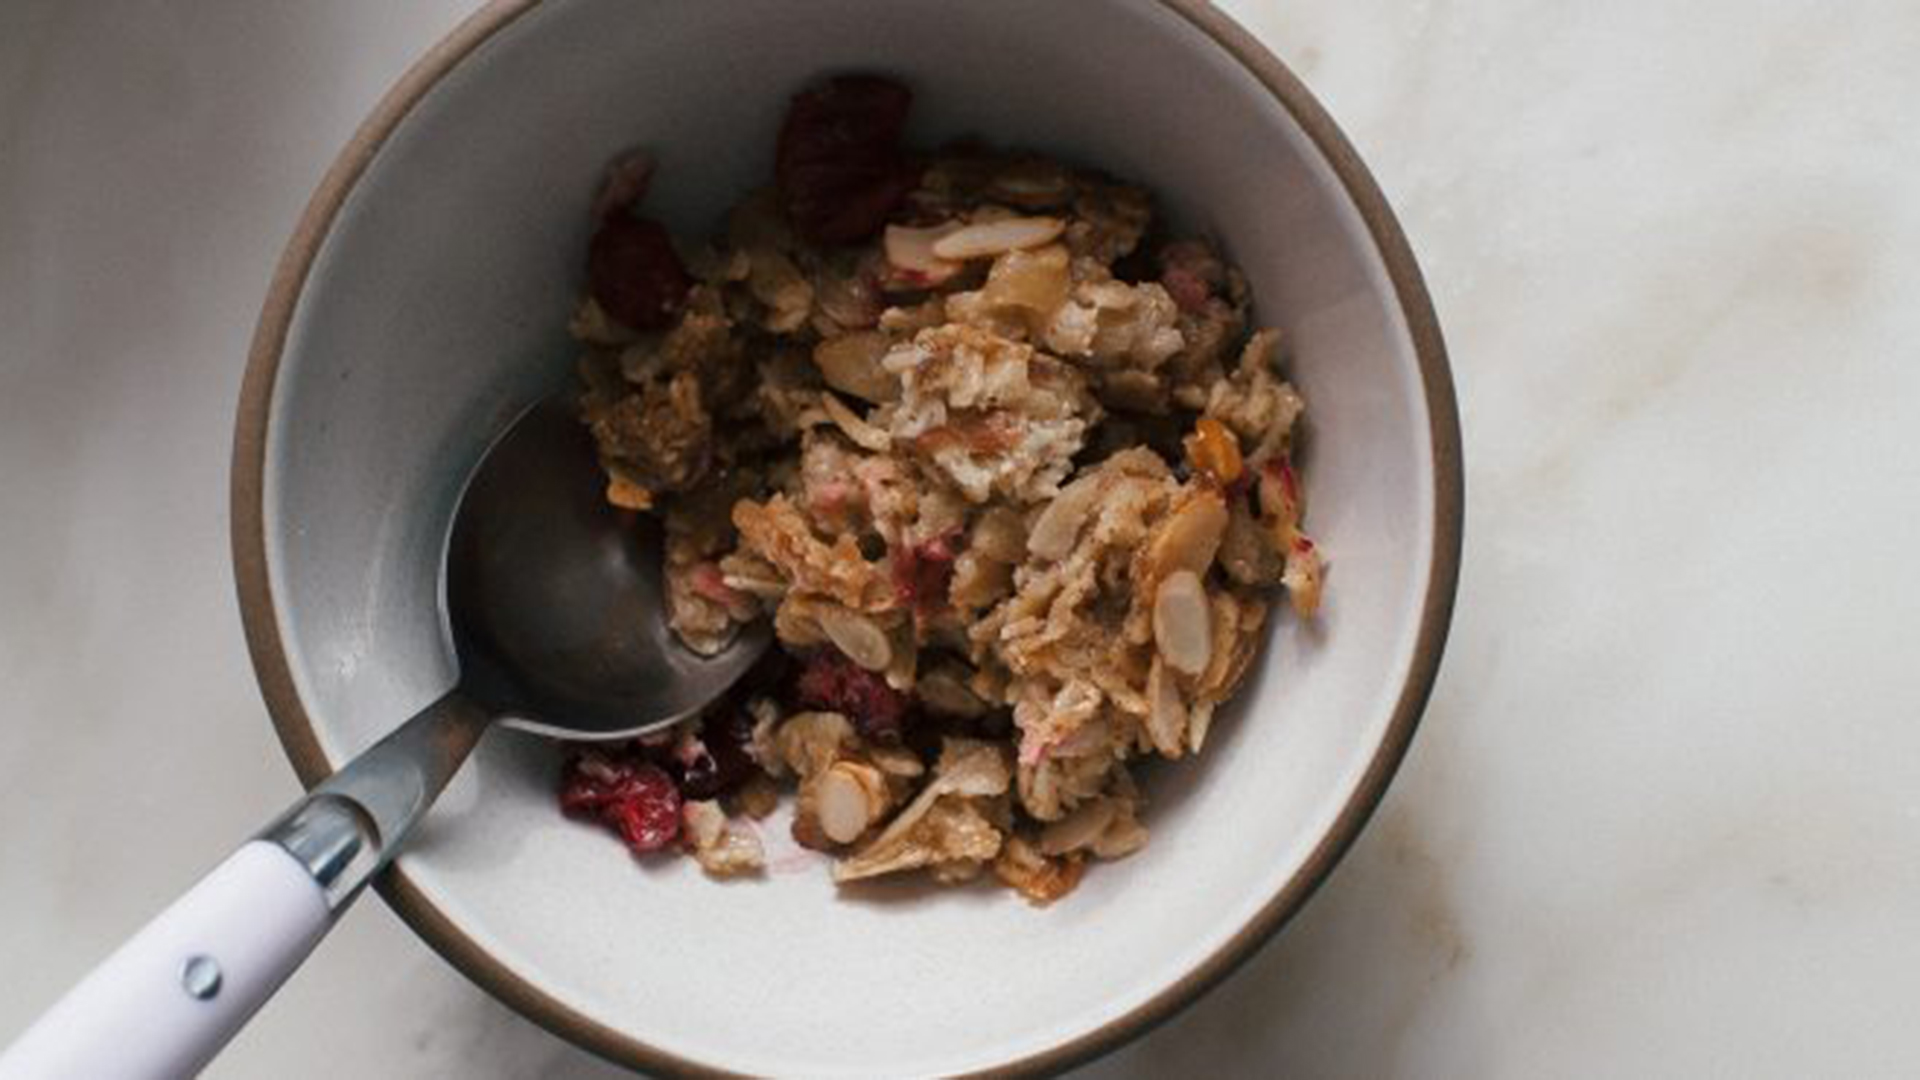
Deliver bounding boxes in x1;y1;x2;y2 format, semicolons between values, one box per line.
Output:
445;398;770;740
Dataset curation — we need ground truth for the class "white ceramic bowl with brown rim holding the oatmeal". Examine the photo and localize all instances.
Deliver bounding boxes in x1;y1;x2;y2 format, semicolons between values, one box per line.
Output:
232;0;1461;1076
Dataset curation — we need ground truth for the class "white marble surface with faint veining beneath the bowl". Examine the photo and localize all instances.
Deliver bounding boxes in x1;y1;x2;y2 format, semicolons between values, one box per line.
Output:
0;0;1920;1080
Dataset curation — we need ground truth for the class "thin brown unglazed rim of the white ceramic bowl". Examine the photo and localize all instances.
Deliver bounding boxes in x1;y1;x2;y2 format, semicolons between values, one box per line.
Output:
228;0;1465;1076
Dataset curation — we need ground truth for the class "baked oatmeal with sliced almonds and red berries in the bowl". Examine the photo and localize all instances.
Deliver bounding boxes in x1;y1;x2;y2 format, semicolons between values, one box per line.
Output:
561;75;1323;903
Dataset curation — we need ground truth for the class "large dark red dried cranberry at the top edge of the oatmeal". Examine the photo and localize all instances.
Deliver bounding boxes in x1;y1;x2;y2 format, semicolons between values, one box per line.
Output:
774;75;920;244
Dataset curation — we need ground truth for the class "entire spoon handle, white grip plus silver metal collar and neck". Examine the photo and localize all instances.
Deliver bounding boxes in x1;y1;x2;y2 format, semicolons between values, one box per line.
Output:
0;692;486;1080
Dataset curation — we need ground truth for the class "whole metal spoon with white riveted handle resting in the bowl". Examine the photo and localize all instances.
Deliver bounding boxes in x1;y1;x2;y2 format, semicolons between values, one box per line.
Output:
0;398;768;1080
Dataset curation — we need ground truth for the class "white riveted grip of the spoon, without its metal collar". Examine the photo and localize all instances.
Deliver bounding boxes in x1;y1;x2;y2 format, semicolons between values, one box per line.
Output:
0;840;332;1080
